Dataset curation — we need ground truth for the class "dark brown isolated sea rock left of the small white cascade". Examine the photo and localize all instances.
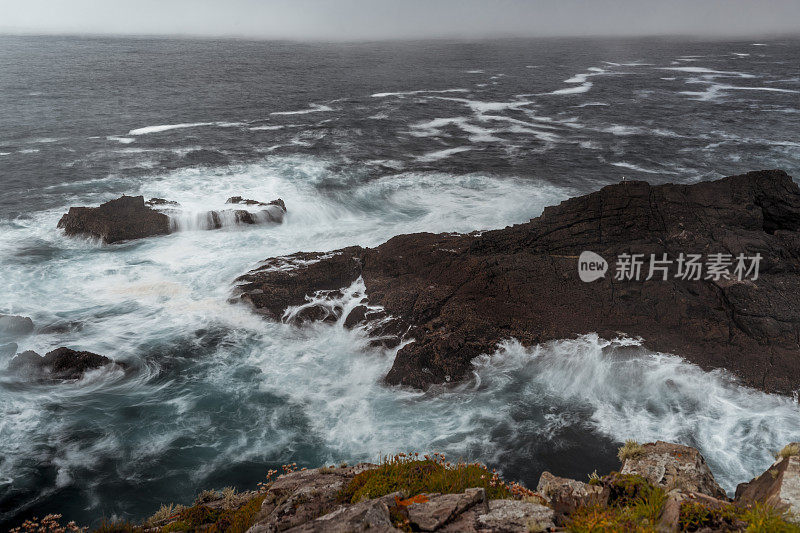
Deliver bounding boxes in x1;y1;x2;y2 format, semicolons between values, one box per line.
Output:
58;196;169;243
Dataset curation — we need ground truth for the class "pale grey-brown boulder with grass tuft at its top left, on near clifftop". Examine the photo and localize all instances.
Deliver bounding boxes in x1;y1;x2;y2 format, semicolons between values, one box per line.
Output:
620;441;727;500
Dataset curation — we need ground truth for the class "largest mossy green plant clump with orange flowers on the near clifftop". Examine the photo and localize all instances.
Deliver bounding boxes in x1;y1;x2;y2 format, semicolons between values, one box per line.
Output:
339;453;516;503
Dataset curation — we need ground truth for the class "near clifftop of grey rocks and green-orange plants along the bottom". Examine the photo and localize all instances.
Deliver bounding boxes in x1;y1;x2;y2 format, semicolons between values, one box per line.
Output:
12;441;800;533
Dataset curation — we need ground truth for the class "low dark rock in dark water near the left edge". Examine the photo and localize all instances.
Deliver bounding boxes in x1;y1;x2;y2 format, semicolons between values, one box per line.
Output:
8;347;124;380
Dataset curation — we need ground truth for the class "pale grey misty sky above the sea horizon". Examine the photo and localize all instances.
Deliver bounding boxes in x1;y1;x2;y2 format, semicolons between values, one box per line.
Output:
0;0;800;40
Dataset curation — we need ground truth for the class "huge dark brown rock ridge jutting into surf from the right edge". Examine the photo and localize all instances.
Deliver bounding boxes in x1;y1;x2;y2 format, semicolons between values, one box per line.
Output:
237;170;800;393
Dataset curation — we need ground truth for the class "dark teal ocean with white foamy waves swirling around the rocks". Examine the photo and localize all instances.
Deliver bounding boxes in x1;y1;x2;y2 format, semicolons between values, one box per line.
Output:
0;36;800;529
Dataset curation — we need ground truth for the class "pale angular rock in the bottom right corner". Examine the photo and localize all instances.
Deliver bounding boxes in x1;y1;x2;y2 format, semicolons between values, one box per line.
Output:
734;442;800;522
